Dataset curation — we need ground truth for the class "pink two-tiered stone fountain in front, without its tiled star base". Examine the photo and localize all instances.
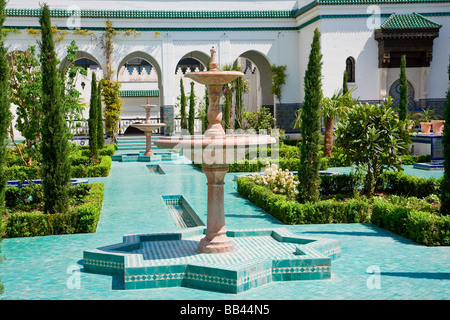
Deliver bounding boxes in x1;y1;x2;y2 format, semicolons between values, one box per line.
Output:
155;48;276;253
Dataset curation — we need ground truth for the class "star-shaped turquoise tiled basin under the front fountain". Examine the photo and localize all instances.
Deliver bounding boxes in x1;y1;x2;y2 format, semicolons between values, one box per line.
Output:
83;227;341;293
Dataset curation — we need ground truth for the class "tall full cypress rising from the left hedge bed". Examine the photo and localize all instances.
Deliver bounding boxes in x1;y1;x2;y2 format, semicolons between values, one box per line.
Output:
39;4;70;213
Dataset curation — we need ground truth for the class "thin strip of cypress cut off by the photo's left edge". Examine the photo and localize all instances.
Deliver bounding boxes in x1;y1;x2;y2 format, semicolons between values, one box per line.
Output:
0;0;11;210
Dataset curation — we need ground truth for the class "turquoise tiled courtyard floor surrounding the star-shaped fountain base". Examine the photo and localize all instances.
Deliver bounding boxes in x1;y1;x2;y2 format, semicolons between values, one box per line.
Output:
0;154;450;300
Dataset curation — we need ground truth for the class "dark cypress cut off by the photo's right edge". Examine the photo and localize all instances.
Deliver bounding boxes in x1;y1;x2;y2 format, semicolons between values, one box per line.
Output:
441;70;450;215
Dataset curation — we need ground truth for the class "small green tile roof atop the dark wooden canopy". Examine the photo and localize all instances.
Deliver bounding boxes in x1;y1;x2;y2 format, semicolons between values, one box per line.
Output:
381;13;441;30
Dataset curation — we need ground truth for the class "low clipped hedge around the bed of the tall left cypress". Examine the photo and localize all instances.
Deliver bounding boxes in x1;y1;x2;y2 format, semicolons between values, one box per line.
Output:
4;182;104;238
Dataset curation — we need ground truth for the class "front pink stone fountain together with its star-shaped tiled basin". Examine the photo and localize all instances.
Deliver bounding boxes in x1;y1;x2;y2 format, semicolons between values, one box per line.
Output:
83;48;341;293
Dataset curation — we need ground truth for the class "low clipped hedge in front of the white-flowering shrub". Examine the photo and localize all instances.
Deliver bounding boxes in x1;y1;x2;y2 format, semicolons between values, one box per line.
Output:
237;178;369;224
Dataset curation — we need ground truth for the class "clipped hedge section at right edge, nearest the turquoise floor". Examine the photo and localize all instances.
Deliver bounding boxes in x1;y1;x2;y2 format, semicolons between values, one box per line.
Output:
371;199;450;246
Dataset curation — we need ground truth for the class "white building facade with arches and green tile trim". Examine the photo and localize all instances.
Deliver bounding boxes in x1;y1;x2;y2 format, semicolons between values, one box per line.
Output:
5;0;450;134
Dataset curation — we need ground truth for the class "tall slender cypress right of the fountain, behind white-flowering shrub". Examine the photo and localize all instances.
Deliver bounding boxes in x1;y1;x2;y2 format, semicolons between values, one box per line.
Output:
298;28;322;202
